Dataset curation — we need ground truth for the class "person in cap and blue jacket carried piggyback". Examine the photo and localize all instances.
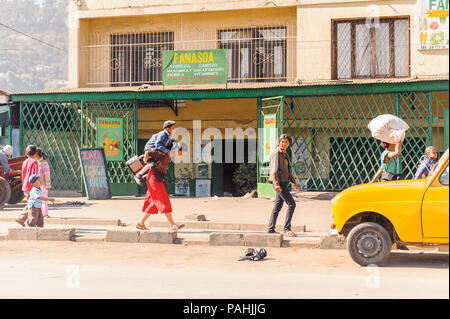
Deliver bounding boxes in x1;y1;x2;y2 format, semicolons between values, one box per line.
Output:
134;120;176;186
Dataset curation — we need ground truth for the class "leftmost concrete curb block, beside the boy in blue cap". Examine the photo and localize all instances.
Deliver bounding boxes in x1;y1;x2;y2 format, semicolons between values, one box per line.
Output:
6;227;75;241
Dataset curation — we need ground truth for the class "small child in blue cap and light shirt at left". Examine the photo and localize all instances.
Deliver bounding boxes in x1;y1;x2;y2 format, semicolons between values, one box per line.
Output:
26;174;55;227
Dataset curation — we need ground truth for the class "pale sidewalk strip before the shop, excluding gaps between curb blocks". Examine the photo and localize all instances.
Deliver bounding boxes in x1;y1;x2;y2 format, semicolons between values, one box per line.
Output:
0;192;335;232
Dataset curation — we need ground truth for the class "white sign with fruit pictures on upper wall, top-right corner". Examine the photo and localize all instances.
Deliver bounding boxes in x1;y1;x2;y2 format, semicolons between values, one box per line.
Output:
417;0;449;50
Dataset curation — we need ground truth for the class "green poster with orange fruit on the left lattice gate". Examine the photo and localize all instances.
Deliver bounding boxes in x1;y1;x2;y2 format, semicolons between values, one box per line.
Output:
97;117;123;161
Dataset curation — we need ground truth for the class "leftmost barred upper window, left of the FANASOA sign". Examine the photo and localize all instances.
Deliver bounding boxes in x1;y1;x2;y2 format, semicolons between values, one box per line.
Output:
110;32;174;86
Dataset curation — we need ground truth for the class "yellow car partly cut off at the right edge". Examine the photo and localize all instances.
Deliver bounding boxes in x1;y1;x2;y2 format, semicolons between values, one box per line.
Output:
332;149;449;266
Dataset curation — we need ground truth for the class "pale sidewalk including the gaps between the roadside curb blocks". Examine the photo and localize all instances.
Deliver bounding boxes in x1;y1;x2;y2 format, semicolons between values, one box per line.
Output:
0;193;334;248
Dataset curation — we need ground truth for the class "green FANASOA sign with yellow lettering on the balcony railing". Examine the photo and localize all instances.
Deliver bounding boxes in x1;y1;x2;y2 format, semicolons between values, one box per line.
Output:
162;49;227;85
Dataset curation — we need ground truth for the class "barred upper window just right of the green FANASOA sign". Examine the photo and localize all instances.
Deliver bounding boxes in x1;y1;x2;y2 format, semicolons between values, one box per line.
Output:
219;27;287;82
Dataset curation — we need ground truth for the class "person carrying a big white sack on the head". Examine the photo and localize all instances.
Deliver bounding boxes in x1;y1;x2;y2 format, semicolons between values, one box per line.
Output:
368;114;409;183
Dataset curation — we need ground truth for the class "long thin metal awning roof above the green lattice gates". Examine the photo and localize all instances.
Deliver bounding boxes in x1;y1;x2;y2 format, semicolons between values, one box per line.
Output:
11;75;449;95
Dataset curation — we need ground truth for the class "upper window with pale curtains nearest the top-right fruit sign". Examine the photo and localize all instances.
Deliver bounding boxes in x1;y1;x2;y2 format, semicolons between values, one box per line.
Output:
332;18;410;79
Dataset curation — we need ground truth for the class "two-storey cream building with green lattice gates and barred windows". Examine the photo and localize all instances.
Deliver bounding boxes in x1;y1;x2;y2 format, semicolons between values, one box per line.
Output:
7;0;450;196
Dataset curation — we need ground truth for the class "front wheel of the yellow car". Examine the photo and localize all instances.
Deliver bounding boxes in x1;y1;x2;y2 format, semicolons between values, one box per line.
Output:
347;222;392;266
